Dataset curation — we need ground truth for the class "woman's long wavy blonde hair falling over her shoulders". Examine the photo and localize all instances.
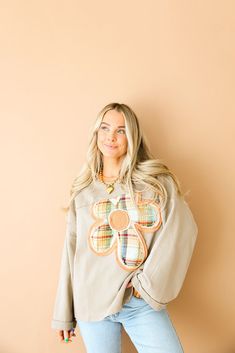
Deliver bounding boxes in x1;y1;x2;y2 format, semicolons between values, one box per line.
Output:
63;103;183;211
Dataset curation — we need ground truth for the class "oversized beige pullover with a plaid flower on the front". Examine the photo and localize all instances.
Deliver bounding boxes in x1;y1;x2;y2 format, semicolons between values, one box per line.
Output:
51;176;198;330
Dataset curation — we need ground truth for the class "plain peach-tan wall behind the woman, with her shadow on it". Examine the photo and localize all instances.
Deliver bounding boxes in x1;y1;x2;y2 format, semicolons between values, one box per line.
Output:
0;0;235;353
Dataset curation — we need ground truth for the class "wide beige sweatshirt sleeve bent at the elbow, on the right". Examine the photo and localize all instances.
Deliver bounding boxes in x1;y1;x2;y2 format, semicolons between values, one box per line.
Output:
131;177;198;310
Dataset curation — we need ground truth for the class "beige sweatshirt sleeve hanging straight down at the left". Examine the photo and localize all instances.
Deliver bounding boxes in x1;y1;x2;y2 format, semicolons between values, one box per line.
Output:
51;202;76;330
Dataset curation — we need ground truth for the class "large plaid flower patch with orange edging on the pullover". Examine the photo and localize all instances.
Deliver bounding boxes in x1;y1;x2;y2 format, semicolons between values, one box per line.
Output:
89;194;162;271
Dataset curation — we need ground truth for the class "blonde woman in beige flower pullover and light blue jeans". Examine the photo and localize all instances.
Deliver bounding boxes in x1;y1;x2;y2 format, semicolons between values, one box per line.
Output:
52;103;198;353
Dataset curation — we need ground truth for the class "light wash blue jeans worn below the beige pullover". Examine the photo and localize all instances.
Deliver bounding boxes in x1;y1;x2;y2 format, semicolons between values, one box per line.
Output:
77;296;183;353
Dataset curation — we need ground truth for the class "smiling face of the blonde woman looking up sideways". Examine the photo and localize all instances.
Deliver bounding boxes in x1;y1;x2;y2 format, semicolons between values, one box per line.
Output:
97;109;127;159
